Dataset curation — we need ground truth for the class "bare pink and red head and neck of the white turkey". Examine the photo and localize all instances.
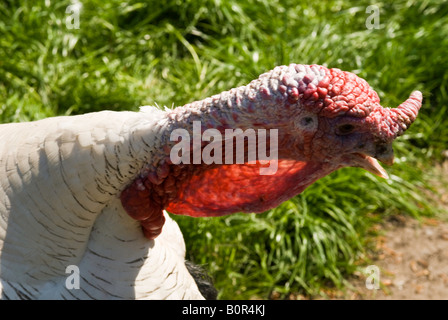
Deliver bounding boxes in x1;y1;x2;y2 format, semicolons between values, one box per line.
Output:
121;64;422;239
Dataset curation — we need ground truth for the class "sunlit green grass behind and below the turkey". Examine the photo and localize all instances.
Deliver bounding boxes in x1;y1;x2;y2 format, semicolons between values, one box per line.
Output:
0;0;448;299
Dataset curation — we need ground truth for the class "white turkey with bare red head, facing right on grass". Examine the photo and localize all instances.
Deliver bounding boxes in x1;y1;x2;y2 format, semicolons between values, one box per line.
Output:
0;64;422;299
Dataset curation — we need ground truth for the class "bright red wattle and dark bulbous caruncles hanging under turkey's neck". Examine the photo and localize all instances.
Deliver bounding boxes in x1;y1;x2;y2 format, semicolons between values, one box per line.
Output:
121;160;336;239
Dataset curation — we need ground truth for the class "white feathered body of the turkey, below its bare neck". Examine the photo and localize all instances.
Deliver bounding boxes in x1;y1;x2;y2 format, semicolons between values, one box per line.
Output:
0;108;203;299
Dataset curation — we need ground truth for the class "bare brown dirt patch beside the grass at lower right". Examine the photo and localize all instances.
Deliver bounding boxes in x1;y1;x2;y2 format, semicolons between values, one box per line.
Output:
343;161;448;300
